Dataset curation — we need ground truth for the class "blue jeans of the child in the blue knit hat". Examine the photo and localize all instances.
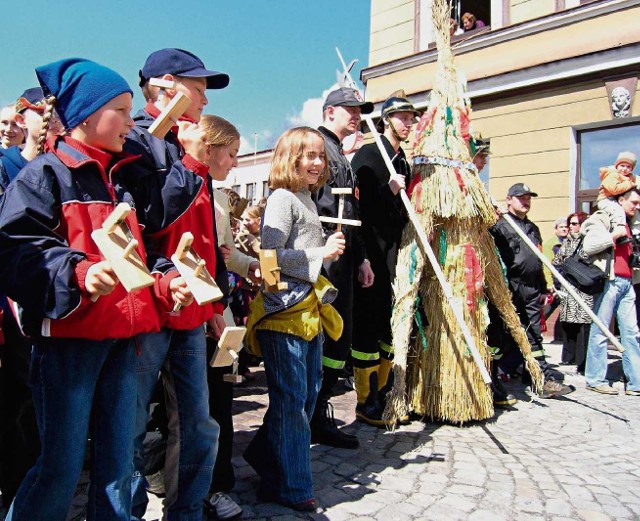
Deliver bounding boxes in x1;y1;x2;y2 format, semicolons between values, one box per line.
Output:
7;338;136;521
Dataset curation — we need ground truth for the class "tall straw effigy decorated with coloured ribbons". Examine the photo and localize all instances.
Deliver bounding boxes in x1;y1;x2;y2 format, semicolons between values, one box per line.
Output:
384;0;543;428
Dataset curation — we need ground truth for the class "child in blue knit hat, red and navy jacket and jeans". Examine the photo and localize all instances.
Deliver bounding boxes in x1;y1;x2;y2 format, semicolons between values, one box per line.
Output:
0;58;192;521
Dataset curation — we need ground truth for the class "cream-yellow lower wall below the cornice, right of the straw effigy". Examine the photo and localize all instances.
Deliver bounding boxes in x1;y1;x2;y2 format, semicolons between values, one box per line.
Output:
471;81;640;238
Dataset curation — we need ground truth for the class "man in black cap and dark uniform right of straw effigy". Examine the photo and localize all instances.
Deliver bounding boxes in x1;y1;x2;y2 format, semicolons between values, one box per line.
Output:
491;183;573;398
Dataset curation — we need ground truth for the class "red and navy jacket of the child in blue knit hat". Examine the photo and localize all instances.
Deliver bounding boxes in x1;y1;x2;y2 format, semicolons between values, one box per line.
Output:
0;137;159;340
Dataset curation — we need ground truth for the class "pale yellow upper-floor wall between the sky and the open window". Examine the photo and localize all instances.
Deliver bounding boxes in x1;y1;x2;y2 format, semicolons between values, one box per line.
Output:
369;0;419;66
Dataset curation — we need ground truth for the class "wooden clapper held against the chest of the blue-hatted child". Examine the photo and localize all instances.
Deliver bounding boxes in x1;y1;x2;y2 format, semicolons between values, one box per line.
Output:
91;203;154;296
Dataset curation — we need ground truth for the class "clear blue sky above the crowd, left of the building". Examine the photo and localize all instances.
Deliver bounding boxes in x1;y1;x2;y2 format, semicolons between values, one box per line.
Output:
0;0;370;150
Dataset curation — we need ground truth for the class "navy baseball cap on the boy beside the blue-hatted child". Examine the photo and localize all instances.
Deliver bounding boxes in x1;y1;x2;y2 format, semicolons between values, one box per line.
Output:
138;48;229;89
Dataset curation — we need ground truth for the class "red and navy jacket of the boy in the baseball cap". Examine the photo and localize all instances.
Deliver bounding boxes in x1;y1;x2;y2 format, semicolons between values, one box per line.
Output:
125;104;229;330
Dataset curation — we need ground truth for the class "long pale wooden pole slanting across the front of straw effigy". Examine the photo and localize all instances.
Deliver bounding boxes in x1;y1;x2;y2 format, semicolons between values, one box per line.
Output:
336;47;491;384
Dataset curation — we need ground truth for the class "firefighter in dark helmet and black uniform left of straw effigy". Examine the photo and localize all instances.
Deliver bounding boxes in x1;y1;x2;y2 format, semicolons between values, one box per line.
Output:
351;91;419;427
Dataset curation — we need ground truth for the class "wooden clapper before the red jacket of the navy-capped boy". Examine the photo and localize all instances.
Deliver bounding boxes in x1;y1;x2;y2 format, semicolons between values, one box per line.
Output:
171;232;224;312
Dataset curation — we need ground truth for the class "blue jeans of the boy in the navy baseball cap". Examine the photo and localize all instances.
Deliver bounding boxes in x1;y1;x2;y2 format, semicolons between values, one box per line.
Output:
132;327;220;521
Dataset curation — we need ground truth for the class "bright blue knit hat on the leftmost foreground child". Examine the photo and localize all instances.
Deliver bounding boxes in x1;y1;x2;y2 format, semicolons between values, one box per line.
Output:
36;58;133;130
